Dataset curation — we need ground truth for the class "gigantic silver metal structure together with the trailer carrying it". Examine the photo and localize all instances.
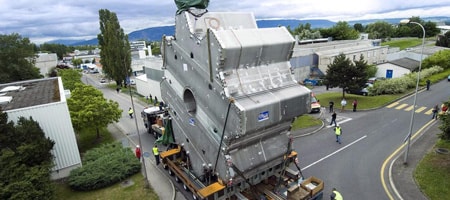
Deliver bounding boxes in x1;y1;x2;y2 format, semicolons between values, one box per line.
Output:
155;1;323;199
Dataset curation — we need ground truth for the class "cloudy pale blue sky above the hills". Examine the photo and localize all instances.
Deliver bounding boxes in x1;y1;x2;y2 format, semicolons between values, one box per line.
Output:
0;0;450;44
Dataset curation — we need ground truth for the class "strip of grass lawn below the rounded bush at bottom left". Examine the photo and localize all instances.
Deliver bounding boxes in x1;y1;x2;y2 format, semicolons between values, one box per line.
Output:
55;173;159;200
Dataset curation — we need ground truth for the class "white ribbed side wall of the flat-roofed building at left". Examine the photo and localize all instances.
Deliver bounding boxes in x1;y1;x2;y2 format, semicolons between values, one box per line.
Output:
6;102;81;171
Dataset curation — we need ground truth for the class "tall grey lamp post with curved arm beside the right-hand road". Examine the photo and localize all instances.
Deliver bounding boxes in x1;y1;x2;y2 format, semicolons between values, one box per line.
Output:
400;19;425;165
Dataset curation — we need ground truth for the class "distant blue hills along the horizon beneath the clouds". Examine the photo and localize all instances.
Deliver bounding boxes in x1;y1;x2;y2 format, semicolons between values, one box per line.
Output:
49;17;450;46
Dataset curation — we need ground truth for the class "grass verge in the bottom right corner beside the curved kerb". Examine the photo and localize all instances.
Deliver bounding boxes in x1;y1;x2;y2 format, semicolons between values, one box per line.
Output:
414;140;450;200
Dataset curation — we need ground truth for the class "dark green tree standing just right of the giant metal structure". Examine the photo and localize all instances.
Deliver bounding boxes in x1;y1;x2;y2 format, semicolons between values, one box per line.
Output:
325;53;368;98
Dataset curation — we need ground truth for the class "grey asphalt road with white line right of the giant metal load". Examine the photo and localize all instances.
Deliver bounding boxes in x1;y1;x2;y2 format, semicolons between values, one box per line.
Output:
294;80;450;200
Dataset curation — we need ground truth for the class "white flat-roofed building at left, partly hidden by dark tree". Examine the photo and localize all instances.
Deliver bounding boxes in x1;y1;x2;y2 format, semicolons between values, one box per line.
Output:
0;77;81;179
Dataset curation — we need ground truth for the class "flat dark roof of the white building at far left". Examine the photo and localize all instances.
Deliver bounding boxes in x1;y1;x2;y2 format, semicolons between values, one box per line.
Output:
0;77;61;111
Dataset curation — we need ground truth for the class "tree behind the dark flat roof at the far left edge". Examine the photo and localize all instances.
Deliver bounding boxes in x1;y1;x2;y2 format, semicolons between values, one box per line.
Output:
0;33;42;83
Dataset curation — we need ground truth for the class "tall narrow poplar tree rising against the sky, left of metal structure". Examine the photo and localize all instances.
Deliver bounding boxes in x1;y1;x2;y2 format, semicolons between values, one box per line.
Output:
97;9;131;85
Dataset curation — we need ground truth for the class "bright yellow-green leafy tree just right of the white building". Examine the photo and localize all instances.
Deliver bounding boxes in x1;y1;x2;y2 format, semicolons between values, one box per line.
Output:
67;83;122;138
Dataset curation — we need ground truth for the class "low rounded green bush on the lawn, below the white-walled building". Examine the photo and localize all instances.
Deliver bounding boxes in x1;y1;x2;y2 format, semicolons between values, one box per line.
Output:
68;143;141;191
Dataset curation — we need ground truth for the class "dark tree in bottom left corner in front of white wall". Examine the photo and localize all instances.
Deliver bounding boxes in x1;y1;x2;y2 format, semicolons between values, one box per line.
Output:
0;109;55;199
